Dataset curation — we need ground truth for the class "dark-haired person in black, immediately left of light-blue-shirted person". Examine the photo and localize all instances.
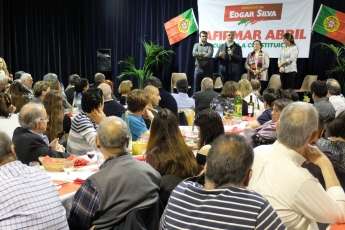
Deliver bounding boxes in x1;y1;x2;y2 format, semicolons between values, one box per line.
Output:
145;77;177;116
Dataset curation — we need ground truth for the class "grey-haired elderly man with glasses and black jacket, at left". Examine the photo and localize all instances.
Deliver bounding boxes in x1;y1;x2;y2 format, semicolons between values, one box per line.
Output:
12;102;64;164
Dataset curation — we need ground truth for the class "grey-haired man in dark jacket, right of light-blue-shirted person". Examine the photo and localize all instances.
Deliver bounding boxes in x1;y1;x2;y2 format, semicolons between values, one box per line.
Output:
193;77;218;113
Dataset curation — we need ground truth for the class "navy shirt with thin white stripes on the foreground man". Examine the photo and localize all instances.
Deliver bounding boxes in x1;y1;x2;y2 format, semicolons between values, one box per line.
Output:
160;180;285;230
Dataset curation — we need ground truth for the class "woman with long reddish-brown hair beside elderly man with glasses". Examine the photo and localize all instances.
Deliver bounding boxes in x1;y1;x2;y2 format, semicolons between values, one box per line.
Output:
43;90;64;141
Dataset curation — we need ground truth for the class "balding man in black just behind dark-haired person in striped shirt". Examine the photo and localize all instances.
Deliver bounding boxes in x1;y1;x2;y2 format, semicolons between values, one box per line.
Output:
98;83;125;117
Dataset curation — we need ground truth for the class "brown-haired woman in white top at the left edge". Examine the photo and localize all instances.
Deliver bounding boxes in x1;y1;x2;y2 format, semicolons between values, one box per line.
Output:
0;93;20;138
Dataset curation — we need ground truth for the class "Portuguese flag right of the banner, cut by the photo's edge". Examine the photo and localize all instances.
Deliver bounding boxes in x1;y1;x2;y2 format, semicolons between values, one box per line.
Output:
313;5;345;44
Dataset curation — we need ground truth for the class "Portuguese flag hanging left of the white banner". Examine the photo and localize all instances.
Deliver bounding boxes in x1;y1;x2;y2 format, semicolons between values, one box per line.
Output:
164;9;198;45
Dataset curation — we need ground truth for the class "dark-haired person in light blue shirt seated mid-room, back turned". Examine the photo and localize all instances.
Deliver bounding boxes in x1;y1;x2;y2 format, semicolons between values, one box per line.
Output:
171;79;195;110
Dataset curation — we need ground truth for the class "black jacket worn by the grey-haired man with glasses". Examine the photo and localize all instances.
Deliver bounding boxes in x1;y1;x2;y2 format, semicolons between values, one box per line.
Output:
12;127;64;164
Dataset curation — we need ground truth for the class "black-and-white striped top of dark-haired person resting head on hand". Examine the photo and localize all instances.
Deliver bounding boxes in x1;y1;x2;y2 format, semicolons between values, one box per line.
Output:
67;112;97;155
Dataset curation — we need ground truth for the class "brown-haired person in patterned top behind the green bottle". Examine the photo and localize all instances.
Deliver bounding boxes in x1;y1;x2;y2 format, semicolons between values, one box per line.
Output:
210;81;248;116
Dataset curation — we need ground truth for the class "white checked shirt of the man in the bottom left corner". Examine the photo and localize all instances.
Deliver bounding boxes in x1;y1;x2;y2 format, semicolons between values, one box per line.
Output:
0;161;68;230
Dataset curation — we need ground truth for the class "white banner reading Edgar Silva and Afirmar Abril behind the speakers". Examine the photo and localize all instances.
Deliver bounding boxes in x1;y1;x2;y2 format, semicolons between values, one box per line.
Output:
198;0;314;58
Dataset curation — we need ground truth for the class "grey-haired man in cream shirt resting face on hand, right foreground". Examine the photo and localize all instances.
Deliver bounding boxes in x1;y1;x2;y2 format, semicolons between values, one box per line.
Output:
249;102;345;230
